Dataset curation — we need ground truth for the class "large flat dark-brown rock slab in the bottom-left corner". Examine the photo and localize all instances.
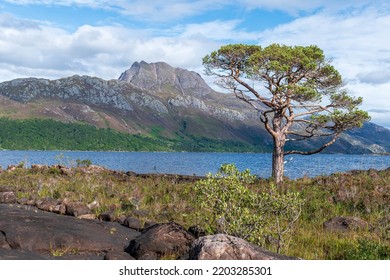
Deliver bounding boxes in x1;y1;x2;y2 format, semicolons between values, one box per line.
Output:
0;204;140;259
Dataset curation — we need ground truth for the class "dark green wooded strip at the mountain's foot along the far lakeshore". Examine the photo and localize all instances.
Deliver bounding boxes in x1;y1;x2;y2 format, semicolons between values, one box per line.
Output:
0;118;269;152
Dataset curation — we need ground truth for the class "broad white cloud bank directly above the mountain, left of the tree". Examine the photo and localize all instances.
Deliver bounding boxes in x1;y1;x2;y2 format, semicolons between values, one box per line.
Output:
0;15;219;80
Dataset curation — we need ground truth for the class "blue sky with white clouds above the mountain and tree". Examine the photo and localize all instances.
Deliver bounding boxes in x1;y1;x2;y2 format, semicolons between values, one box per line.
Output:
0;0;390;128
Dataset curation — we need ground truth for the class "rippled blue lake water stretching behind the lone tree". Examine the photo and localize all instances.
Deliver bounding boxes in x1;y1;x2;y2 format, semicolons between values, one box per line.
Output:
0;151;390;179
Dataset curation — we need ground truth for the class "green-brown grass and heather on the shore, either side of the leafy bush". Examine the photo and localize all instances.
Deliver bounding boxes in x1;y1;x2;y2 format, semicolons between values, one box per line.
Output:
0;165;390;260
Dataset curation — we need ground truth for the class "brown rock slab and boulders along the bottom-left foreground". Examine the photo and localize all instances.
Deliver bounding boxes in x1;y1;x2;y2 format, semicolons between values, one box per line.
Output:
0;190;292;260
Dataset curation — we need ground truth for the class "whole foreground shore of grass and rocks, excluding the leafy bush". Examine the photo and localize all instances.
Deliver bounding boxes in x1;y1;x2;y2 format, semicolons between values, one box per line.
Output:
0;165;390;260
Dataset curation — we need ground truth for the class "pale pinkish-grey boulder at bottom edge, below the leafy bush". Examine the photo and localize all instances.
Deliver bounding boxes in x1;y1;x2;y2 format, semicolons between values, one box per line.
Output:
189;234;294;260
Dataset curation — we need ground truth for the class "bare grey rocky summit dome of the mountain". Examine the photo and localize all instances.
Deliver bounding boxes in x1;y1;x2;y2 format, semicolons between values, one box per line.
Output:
119;61;212;96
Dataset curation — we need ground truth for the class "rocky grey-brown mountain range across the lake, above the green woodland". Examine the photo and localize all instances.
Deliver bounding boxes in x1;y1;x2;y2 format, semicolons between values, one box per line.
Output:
0;61;390;153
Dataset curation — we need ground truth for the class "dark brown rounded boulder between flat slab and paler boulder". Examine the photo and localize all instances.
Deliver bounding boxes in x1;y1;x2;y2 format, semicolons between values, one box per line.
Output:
125;223;194;260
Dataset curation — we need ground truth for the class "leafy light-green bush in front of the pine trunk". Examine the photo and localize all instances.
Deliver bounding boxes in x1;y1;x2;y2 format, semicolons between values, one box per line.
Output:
196;164;303;252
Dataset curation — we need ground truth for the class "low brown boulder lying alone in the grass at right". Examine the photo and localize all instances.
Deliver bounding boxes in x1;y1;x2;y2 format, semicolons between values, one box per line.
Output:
323;217;371;231
